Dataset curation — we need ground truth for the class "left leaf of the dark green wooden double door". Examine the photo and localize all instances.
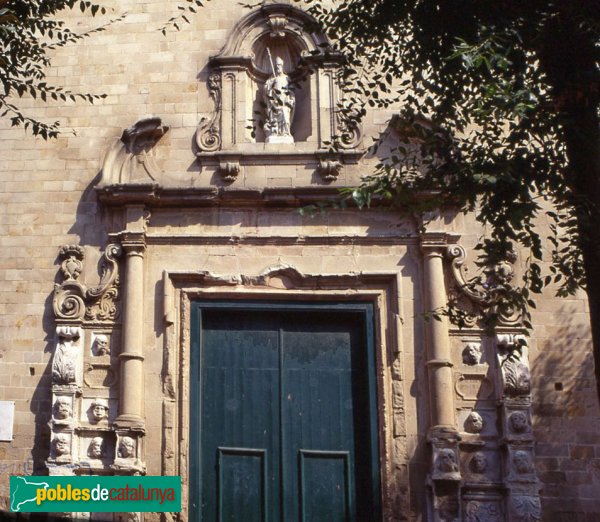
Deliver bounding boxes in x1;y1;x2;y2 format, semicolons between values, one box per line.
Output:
200;311;280;522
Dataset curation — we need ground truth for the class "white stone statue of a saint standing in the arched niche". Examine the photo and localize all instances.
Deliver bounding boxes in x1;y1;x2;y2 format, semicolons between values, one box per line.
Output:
264;53;296;143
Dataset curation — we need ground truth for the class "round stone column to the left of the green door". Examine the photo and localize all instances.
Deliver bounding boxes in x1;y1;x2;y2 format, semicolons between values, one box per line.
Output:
115;207;146;431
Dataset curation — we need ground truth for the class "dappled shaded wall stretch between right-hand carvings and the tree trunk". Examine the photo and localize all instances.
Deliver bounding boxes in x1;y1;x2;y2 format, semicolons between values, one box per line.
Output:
532;303;600;520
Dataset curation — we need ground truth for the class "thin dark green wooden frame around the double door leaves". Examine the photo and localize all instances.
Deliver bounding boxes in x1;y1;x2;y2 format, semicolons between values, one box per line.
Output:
188;299;382;522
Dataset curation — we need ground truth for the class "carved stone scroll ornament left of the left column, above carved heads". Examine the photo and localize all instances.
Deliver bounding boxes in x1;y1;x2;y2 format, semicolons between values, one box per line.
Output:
52;244;121;321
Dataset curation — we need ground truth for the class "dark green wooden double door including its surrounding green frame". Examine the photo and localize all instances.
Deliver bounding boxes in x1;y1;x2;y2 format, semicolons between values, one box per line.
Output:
190;303;380;522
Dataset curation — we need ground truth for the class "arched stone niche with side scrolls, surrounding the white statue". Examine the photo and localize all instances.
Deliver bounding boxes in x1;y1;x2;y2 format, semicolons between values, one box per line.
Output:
196;4;360;179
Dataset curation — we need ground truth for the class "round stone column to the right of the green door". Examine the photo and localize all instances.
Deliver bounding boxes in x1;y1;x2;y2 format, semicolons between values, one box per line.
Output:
421;238;456;429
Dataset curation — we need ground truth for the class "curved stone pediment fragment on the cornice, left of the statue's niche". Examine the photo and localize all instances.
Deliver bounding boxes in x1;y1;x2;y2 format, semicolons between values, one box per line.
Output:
99;117;169;187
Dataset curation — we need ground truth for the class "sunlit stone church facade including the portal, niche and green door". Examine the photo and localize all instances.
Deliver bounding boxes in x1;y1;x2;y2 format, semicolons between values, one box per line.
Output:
0;0;600;522
